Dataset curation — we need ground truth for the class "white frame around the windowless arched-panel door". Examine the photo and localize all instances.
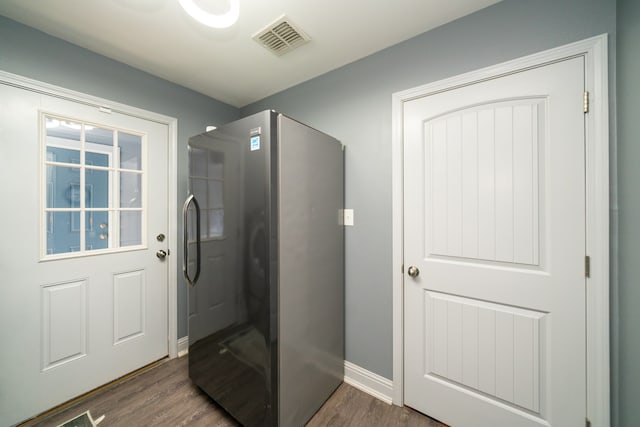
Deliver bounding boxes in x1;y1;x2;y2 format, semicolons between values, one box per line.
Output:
392;34;610;427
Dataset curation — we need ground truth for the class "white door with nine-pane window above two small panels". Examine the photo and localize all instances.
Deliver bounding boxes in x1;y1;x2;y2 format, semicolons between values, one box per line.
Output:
0;84;168;425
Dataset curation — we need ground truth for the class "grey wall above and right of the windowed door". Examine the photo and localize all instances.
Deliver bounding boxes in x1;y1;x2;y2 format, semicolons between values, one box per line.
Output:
0;16;239;337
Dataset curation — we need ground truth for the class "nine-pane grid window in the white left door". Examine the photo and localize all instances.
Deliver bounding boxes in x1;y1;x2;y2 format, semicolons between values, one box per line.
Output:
42;114;146;257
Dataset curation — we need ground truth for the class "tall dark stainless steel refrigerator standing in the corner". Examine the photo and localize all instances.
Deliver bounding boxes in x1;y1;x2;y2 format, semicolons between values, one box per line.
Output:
183;111;344;427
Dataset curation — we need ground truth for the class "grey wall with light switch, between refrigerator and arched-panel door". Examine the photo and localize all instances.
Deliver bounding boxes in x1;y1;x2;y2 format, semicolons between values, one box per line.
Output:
242;0;616;378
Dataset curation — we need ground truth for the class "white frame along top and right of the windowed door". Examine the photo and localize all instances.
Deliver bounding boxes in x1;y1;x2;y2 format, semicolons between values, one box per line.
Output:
0;70;178;359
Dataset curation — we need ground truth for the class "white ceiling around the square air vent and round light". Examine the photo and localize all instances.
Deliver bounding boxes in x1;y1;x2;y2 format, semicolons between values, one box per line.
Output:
0;0;499;107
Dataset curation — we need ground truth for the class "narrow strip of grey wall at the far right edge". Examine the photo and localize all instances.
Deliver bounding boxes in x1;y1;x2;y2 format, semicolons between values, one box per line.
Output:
612;0;640;427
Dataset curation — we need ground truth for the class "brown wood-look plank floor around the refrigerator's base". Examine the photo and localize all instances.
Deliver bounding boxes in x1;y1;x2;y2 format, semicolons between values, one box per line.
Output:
23;357;446;427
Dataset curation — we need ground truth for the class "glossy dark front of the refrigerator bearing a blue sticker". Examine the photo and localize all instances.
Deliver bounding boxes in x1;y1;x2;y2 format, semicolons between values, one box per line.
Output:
188;112;277;426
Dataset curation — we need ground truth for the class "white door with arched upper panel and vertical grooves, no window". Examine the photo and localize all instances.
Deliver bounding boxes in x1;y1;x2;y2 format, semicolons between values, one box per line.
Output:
403;58;586;427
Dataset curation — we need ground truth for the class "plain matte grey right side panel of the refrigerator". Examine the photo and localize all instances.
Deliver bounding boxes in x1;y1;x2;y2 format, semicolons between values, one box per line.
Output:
278;116;344;426
